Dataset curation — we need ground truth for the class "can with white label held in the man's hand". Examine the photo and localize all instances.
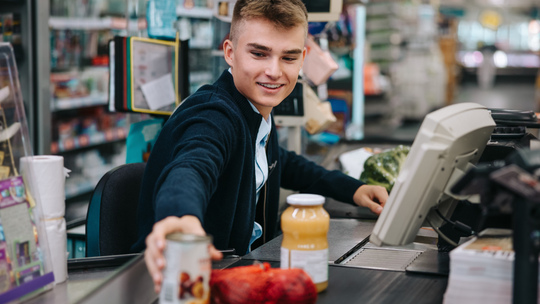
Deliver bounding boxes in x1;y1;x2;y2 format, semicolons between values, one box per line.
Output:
159;233;212;304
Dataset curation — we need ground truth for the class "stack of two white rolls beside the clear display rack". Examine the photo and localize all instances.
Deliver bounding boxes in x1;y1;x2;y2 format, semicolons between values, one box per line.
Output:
20;155;67;283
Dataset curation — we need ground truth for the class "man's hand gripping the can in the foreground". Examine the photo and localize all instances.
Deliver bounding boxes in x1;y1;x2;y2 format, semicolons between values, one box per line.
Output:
144;215;223;293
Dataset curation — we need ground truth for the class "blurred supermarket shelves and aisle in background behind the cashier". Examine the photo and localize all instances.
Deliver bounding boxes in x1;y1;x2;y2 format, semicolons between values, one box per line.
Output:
0;0;540;257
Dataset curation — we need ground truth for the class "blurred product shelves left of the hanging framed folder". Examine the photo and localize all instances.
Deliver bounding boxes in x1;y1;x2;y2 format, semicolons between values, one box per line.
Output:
46;0;133;203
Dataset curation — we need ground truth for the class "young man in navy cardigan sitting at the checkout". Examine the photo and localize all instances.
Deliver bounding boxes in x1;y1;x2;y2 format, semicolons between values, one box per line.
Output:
132;0;388;291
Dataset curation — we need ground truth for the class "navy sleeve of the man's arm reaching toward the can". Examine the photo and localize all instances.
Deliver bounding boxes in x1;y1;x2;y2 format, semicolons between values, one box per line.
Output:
151;102;238;224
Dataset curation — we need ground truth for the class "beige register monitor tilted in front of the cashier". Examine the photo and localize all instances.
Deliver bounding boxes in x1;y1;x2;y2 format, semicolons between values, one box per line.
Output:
370;103;495;246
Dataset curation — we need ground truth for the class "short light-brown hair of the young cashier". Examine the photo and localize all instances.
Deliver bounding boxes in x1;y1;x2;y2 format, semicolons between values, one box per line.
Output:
229;0;308;44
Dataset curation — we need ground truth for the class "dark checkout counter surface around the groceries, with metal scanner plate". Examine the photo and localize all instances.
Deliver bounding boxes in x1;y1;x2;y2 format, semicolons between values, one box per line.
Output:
25;143;448;304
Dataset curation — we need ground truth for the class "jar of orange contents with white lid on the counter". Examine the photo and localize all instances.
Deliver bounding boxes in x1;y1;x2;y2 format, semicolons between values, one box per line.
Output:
281;194;330;292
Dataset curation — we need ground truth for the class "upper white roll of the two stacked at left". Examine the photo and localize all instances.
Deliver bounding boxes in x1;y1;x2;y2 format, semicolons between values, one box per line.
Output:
20;155;69;219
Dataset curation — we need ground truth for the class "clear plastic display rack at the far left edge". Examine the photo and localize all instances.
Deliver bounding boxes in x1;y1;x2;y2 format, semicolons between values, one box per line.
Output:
0;43;54;303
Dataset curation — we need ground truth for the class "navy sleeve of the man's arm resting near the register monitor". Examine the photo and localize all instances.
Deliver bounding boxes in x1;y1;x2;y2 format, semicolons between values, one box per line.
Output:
279;147;364;205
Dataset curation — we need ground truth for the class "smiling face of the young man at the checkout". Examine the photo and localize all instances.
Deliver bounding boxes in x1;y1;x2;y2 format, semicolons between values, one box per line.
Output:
223;19;306;118
